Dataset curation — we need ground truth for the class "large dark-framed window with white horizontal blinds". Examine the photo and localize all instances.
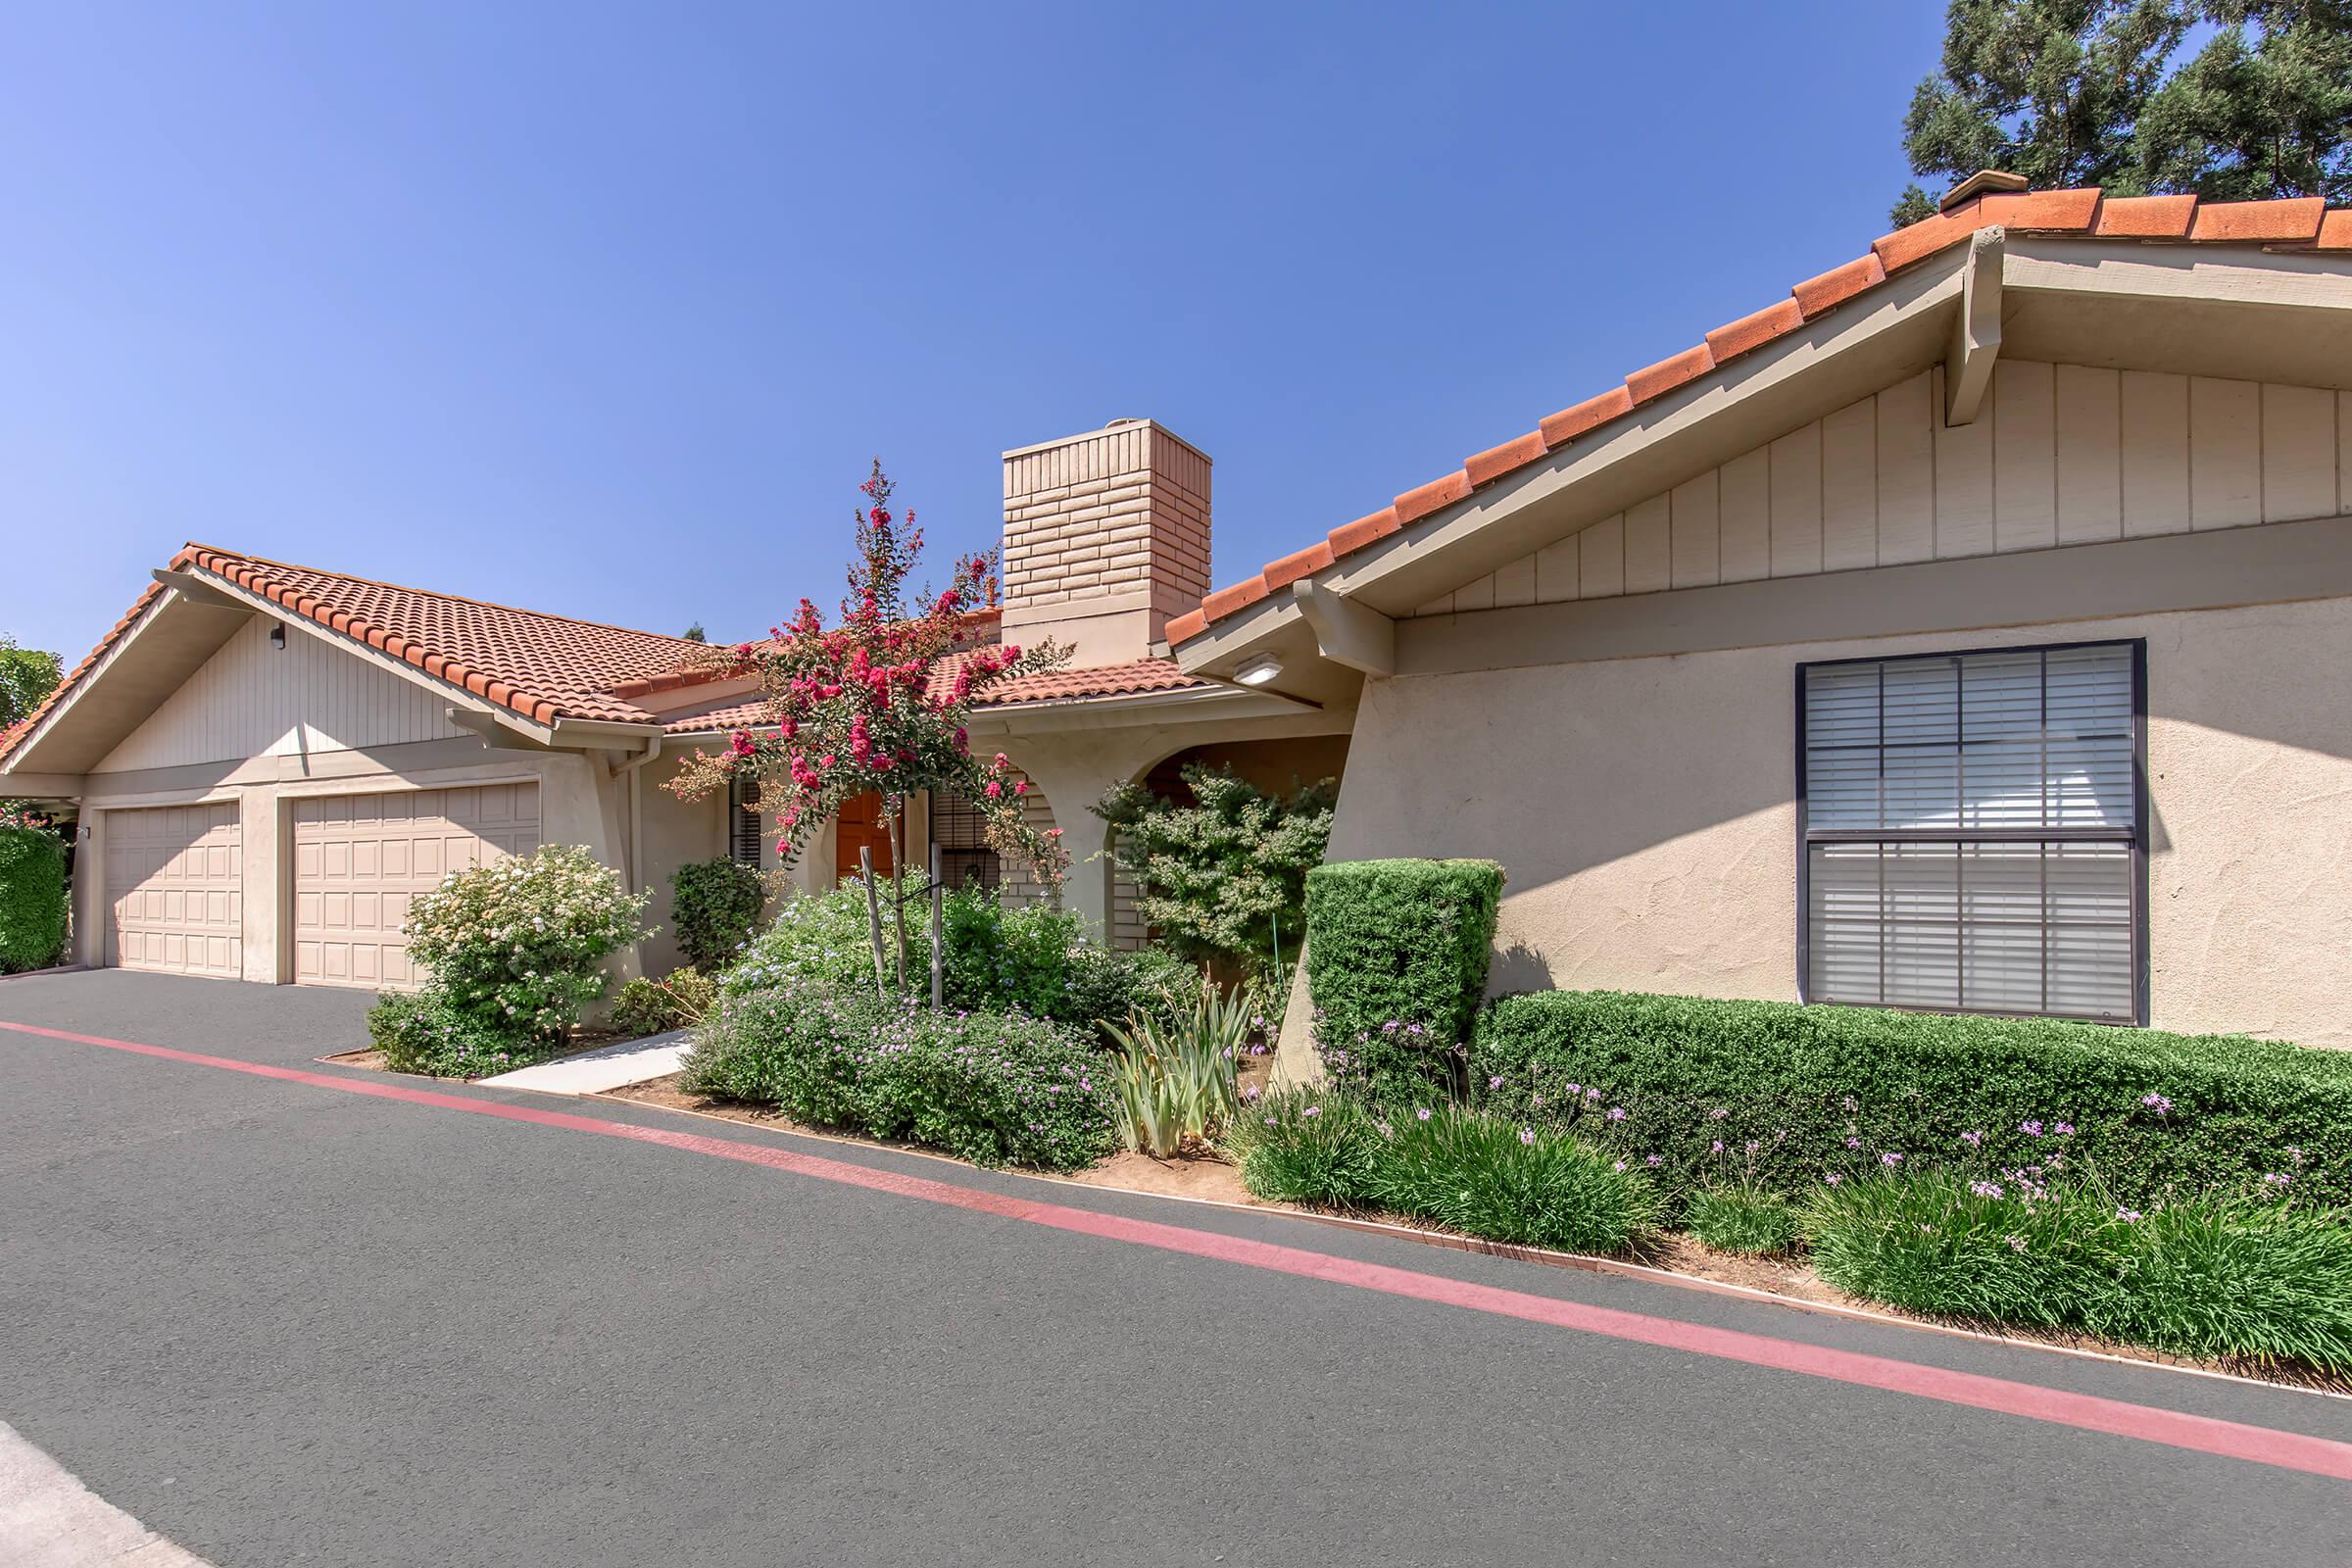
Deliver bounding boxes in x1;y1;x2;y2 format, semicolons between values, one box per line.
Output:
1797;642;2147;1022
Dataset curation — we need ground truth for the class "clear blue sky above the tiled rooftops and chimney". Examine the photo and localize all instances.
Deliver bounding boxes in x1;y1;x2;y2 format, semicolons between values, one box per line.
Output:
0;2;1942;662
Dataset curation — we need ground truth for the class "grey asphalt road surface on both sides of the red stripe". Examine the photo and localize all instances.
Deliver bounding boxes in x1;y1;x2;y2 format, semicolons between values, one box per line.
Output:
0;971;2352;1568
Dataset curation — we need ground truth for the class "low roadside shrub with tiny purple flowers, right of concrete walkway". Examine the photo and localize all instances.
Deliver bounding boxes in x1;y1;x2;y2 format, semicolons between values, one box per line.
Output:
682;980;1117;1171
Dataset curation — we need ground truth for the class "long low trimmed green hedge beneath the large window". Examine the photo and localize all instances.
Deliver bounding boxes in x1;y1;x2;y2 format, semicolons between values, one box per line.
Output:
1470;992;2352;1208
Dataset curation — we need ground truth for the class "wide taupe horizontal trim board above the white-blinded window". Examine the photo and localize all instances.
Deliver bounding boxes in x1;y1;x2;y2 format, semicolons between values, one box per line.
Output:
1397;505;2352;674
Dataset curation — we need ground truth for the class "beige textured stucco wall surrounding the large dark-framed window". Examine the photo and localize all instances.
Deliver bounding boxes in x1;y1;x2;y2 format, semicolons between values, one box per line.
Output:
1331;597;2352;1046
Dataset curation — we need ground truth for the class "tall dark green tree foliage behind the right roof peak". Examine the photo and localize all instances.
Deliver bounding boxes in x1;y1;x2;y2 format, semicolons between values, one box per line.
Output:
1893;0;2352;225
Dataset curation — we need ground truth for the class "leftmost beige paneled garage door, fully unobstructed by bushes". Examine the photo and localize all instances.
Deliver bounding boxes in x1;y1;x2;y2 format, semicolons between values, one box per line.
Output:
106;800;245;980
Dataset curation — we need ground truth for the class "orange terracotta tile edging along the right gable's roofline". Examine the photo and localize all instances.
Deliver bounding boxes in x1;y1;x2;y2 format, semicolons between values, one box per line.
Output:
1166;188;2352;644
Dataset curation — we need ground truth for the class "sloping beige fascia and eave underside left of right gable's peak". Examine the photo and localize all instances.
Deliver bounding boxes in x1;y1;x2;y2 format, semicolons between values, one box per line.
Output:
1176;247;1969;672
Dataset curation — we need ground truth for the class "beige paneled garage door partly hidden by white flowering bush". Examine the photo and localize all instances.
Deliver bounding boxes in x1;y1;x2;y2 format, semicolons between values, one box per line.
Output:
294;783;539;990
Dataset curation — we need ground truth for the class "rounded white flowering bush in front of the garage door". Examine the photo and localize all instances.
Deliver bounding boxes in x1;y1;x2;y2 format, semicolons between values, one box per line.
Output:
402;844;652;1039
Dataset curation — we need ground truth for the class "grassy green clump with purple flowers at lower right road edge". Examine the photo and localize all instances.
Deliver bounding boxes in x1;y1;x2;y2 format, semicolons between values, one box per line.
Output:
1804;1171;2352;1371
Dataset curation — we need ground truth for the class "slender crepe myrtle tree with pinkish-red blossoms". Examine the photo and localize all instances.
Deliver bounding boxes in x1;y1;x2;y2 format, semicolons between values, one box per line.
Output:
670;459;1070;992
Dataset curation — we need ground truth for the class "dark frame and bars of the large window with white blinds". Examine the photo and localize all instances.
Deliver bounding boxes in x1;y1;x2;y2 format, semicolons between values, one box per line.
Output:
1794;637;2150;1030
